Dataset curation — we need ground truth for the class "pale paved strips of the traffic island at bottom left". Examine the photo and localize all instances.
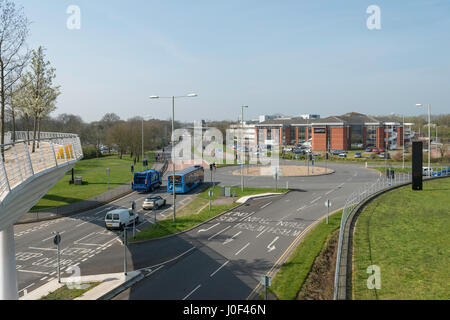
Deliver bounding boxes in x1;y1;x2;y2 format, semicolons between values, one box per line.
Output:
20;271;143;300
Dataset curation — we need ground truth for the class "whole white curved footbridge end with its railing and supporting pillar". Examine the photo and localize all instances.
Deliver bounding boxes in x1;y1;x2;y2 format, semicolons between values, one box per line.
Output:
0;132;83;300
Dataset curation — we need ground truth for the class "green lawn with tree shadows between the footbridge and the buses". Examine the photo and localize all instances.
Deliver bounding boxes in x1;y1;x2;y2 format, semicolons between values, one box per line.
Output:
32;156;154;211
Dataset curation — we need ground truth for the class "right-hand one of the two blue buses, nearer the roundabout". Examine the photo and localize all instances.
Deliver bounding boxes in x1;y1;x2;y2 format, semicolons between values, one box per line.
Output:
167;166;205;193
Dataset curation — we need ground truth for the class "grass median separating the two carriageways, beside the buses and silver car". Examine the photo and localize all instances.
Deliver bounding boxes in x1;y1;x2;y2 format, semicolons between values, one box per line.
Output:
134;187;287;241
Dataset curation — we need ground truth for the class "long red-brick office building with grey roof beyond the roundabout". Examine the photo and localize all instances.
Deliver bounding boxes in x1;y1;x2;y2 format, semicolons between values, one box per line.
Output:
255;112;414;151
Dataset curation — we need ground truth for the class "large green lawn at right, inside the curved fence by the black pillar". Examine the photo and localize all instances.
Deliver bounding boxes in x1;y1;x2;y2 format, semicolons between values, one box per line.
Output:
353;178;450;300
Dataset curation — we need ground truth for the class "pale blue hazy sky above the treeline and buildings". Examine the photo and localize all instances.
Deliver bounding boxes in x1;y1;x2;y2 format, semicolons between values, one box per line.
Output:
15;0;450;122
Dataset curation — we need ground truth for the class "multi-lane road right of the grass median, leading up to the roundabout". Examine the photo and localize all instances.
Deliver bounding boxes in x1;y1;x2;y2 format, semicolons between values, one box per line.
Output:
115;165;379;300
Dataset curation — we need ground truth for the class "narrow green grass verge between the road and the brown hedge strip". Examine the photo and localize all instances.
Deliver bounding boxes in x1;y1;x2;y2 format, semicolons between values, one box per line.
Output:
270;211;342;300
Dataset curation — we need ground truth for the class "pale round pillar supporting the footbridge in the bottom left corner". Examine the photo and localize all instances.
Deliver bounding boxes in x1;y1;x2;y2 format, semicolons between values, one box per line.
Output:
0;225;18;300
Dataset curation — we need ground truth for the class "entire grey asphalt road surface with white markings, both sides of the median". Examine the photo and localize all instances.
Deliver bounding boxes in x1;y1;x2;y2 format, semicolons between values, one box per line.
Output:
15;161;379;300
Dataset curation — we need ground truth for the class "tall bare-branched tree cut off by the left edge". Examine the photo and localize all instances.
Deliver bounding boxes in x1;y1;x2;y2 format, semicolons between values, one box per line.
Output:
0;0;29;148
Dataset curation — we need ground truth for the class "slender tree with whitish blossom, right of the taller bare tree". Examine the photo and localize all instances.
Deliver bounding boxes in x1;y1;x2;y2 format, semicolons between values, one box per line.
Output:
23;46;60;152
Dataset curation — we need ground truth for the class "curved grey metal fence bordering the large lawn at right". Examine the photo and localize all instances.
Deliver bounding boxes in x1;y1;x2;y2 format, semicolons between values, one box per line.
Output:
334;168;450;300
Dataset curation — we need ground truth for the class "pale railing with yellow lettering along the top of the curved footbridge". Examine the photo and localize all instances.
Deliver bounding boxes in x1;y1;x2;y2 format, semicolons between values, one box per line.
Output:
0;131;83;201
